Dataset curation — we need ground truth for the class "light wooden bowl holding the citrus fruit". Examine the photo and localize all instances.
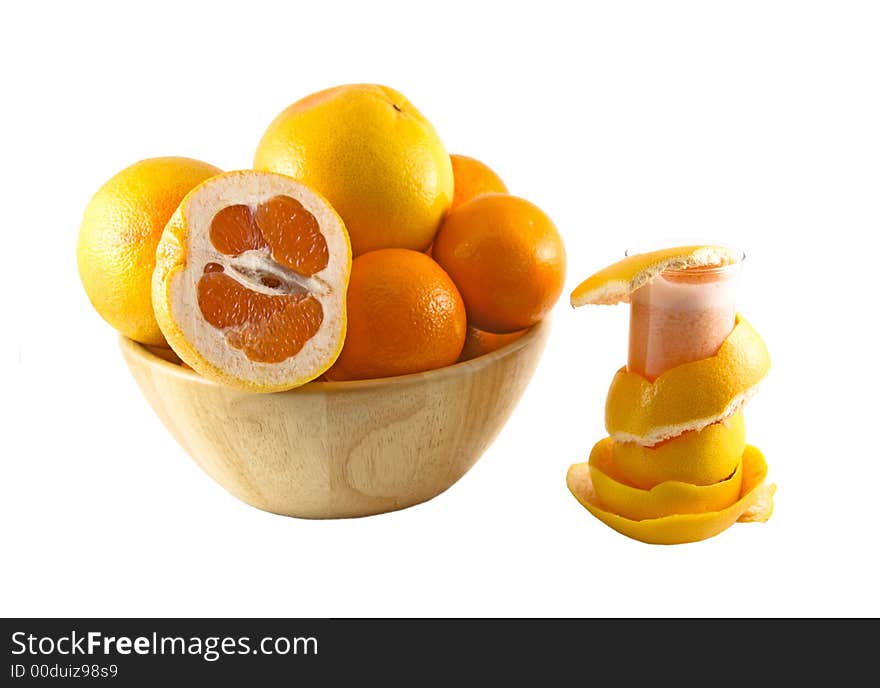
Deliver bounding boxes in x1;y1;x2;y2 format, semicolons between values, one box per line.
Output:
120;320;550;518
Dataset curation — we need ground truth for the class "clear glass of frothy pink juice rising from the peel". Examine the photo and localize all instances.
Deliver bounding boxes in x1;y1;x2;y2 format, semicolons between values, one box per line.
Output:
626;249;745;381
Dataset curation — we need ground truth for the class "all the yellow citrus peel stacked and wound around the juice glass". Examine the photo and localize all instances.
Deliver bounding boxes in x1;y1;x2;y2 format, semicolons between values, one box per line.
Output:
567;246;775;544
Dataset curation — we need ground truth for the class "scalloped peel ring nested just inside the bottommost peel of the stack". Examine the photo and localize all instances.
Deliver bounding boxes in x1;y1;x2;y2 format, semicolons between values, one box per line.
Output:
589;437;742;521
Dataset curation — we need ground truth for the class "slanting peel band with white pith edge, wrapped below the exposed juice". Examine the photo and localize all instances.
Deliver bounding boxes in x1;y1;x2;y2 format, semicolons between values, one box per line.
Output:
605;315;770;446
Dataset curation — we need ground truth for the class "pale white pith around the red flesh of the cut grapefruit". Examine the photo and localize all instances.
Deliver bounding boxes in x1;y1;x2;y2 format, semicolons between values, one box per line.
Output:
170;172;350;387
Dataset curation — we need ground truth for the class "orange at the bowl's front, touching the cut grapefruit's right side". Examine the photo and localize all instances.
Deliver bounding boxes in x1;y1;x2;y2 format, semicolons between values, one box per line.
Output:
327;249;467;380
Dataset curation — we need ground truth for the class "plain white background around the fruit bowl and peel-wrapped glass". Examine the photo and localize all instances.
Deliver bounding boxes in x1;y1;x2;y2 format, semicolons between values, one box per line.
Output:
0;0;880;616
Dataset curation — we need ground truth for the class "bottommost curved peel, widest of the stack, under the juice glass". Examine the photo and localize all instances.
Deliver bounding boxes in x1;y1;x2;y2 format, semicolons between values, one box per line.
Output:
566;445;776;545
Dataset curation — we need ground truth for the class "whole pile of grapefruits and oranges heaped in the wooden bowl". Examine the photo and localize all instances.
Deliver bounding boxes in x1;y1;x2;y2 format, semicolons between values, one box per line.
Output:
77;84;565;392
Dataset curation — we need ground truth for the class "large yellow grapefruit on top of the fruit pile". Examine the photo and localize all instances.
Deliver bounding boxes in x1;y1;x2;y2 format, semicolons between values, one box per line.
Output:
254;84;453;256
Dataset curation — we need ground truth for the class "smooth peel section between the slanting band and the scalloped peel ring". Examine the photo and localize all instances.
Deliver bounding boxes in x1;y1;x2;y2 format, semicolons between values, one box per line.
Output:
613;411;746;490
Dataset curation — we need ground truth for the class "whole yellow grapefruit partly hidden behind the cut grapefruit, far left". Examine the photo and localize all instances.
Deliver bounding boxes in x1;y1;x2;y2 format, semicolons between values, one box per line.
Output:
76;158;221;345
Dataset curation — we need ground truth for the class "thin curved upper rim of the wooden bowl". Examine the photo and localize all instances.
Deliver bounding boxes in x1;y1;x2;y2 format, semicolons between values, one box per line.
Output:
119;315;550;394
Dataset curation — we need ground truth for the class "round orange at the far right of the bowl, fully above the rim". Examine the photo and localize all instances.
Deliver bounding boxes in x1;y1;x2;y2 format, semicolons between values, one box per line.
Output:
432;194;565;333
